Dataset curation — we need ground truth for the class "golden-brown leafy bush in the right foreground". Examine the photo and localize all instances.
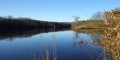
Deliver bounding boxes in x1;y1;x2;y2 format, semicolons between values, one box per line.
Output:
99;10;120;60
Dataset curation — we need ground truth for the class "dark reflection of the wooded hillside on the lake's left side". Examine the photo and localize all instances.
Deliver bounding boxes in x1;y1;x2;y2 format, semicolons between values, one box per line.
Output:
0;28;69;41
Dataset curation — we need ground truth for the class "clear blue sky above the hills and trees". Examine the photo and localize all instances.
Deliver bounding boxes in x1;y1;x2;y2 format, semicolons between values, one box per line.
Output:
0;0;120;22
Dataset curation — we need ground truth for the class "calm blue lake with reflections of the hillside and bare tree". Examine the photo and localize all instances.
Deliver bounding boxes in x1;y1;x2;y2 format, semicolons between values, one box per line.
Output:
0;30;109;60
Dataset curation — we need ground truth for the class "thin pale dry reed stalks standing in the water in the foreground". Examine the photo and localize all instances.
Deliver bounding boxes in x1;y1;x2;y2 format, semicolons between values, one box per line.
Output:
27;32;57;60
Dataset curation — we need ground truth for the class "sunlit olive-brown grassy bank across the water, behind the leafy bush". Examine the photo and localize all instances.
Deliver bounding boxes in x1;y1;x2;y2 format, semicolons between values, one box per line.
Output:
72;20;105;30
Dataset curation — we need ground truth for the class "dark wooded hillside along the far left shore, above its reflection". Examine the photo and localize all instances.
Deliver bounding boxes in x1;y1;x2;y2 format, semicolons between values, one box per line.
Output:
0;16;71;30
